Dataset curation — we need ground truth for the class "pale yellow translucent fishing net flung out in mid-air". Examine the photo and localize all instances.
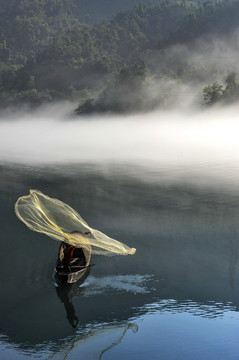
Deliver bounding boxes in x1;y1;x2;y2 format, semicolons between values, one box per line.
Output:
15;190;136;255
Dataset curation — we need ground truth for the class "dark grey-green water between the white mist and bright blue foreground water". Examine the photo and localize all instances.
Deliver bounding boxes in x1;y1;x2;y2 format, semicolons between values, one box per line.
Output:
0;167;239;354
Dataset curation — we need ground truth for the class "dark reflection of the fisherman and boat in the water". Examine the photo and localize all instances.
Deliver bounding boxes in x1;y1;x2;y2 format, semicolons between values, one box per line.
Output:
56;284;79;328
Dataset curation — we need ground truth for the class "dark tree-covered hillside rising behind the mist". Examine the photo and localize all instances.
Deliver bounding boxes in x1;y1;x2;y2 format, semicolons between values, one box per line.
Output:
0;0;239;114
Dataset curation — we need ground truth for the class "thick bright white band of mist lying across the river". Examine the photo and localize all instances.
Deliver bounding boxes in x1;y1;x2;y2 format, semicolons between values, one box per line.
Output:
0;106;239;186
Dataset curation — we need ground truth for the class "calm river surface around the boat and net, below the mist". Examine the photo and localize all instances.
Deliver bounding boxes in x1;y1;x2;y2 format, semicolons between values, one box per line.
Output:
0;108;239;360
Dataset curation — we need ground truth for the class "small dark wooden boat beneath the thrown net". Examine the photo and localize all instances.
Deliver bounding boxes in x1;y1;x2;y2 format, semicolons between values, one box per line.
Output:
54;242;91;284
